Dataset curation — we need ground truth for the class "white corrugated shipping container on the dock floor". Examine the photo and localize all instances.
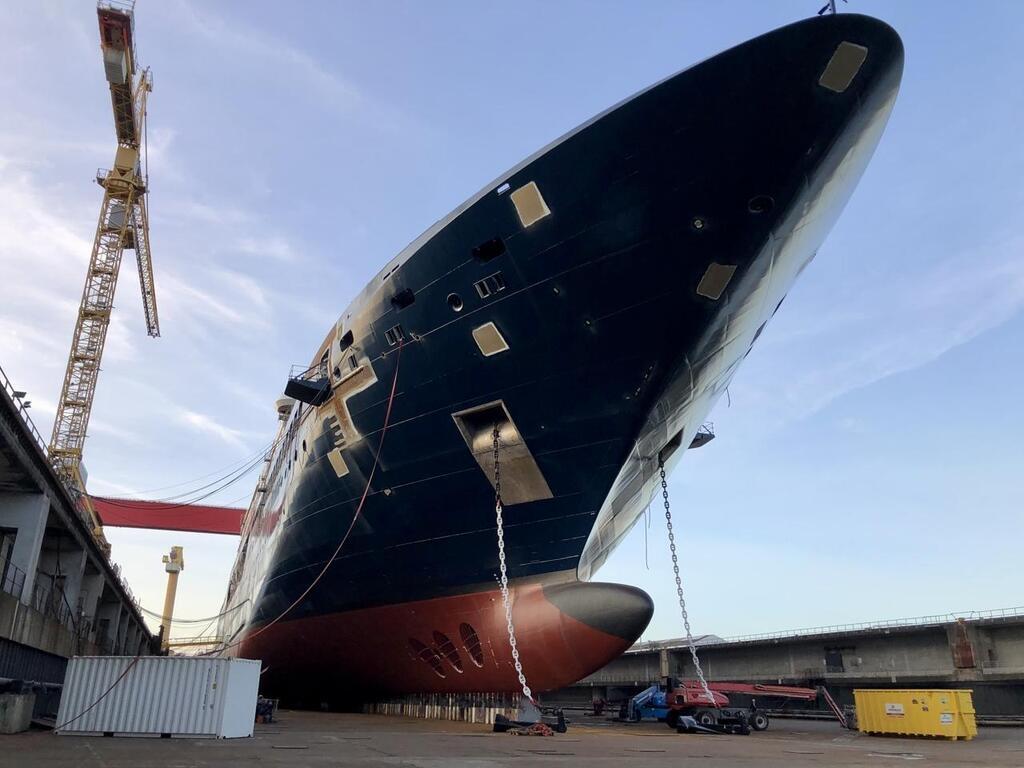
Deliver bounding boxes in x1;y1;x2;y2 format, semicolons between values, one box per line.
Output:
56;656;260;738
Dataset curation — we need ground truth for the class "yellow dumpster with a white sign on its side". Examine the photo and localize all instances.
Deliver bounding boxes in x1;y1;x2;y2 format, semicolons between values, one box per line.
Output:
853;688;978;739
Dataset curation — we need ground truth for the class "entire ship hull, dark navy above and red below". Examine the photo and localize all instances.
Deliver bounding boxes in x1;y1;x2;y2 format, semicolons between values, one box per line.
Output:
222;14;902;691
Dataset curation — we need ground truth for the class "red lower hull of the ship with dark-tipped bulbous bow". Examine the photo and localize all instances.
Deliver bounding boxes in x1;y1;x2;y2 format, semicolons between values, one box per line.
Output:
242;583;653;703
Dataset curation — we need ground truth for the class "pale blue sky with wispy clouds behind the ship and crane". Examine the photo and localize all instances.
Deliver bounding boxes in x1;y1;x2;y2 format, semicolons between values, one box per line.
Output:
0;0;1024;639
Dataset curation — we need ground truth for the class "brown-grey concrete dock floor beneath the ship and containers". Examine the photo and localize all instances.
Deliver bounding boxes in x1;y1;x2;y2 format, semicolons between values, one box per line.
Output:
0;712;1024;768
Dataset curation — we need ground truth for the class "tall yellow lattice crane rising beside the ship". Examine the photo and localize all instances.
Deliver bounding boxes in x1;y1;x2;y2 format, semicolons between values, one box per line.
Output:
49;0;160;548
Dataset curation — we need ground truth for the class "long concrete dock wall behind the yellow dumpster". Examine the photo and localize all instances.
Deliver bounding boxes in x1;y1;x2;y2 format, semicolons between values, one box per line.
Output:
561;608;1024;716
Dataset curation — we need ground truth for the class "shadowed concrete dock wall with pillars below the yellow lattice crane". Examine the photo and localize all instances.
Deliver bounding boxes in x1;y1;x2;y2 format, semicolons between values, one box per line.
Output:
0;370;153;683
